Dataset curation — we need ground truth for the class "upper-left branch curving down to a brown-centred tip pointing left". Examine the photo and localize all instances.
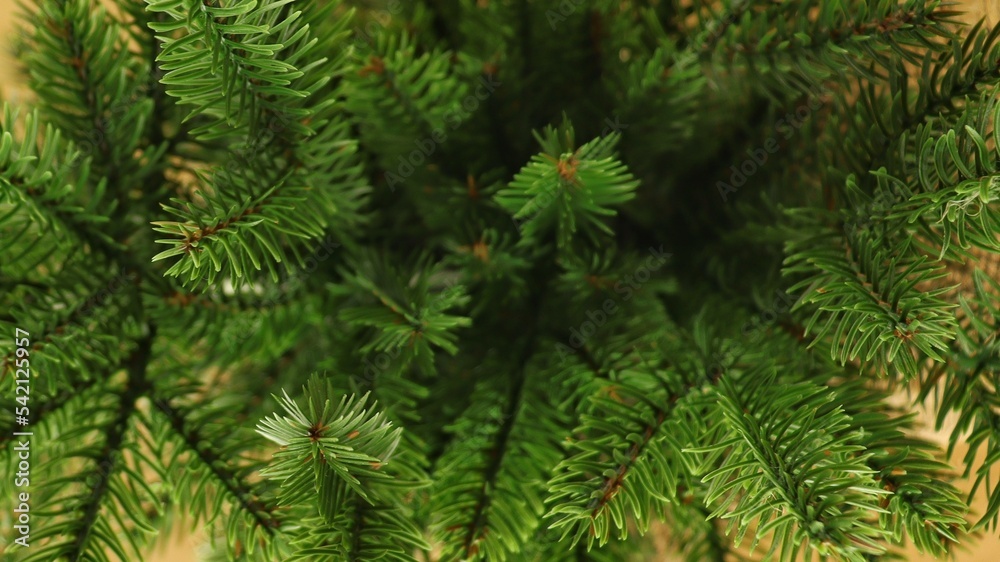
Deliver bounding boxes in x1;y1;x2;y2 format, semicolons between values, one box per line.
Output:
148;1;369;287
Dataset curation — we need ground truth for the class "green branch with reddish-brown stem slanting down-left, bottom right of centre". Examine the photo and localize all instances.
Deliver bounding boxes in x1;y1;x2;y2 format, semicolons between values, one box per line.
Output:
546;342;721;547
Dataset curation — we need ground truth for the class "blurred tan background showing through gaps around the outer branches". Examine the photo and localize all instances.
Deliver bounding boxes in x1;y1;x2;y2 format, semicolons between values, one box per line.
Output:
0;0;1000;562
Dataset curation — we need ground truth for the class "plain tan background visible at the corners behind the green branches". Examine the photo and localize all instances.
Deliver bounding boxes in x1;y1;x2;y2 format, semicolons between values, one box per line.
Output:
0;0;1000;562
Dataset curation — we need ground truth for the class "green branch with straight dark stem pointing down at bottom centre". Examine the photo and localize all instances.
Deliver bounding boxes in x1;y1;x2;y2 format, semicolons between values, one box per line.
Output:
430;280;565;561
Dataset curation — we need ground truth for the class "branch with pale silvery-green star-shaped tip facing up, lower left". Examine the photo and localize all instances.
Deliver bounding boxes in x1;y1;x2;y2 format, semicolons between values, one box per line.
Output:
258;376;426;561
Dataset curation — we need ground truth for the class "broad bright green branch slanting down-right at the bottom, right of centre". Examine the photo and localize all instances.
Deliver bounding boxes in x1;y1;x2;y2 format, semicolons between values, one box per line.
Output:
692;371;886;562
